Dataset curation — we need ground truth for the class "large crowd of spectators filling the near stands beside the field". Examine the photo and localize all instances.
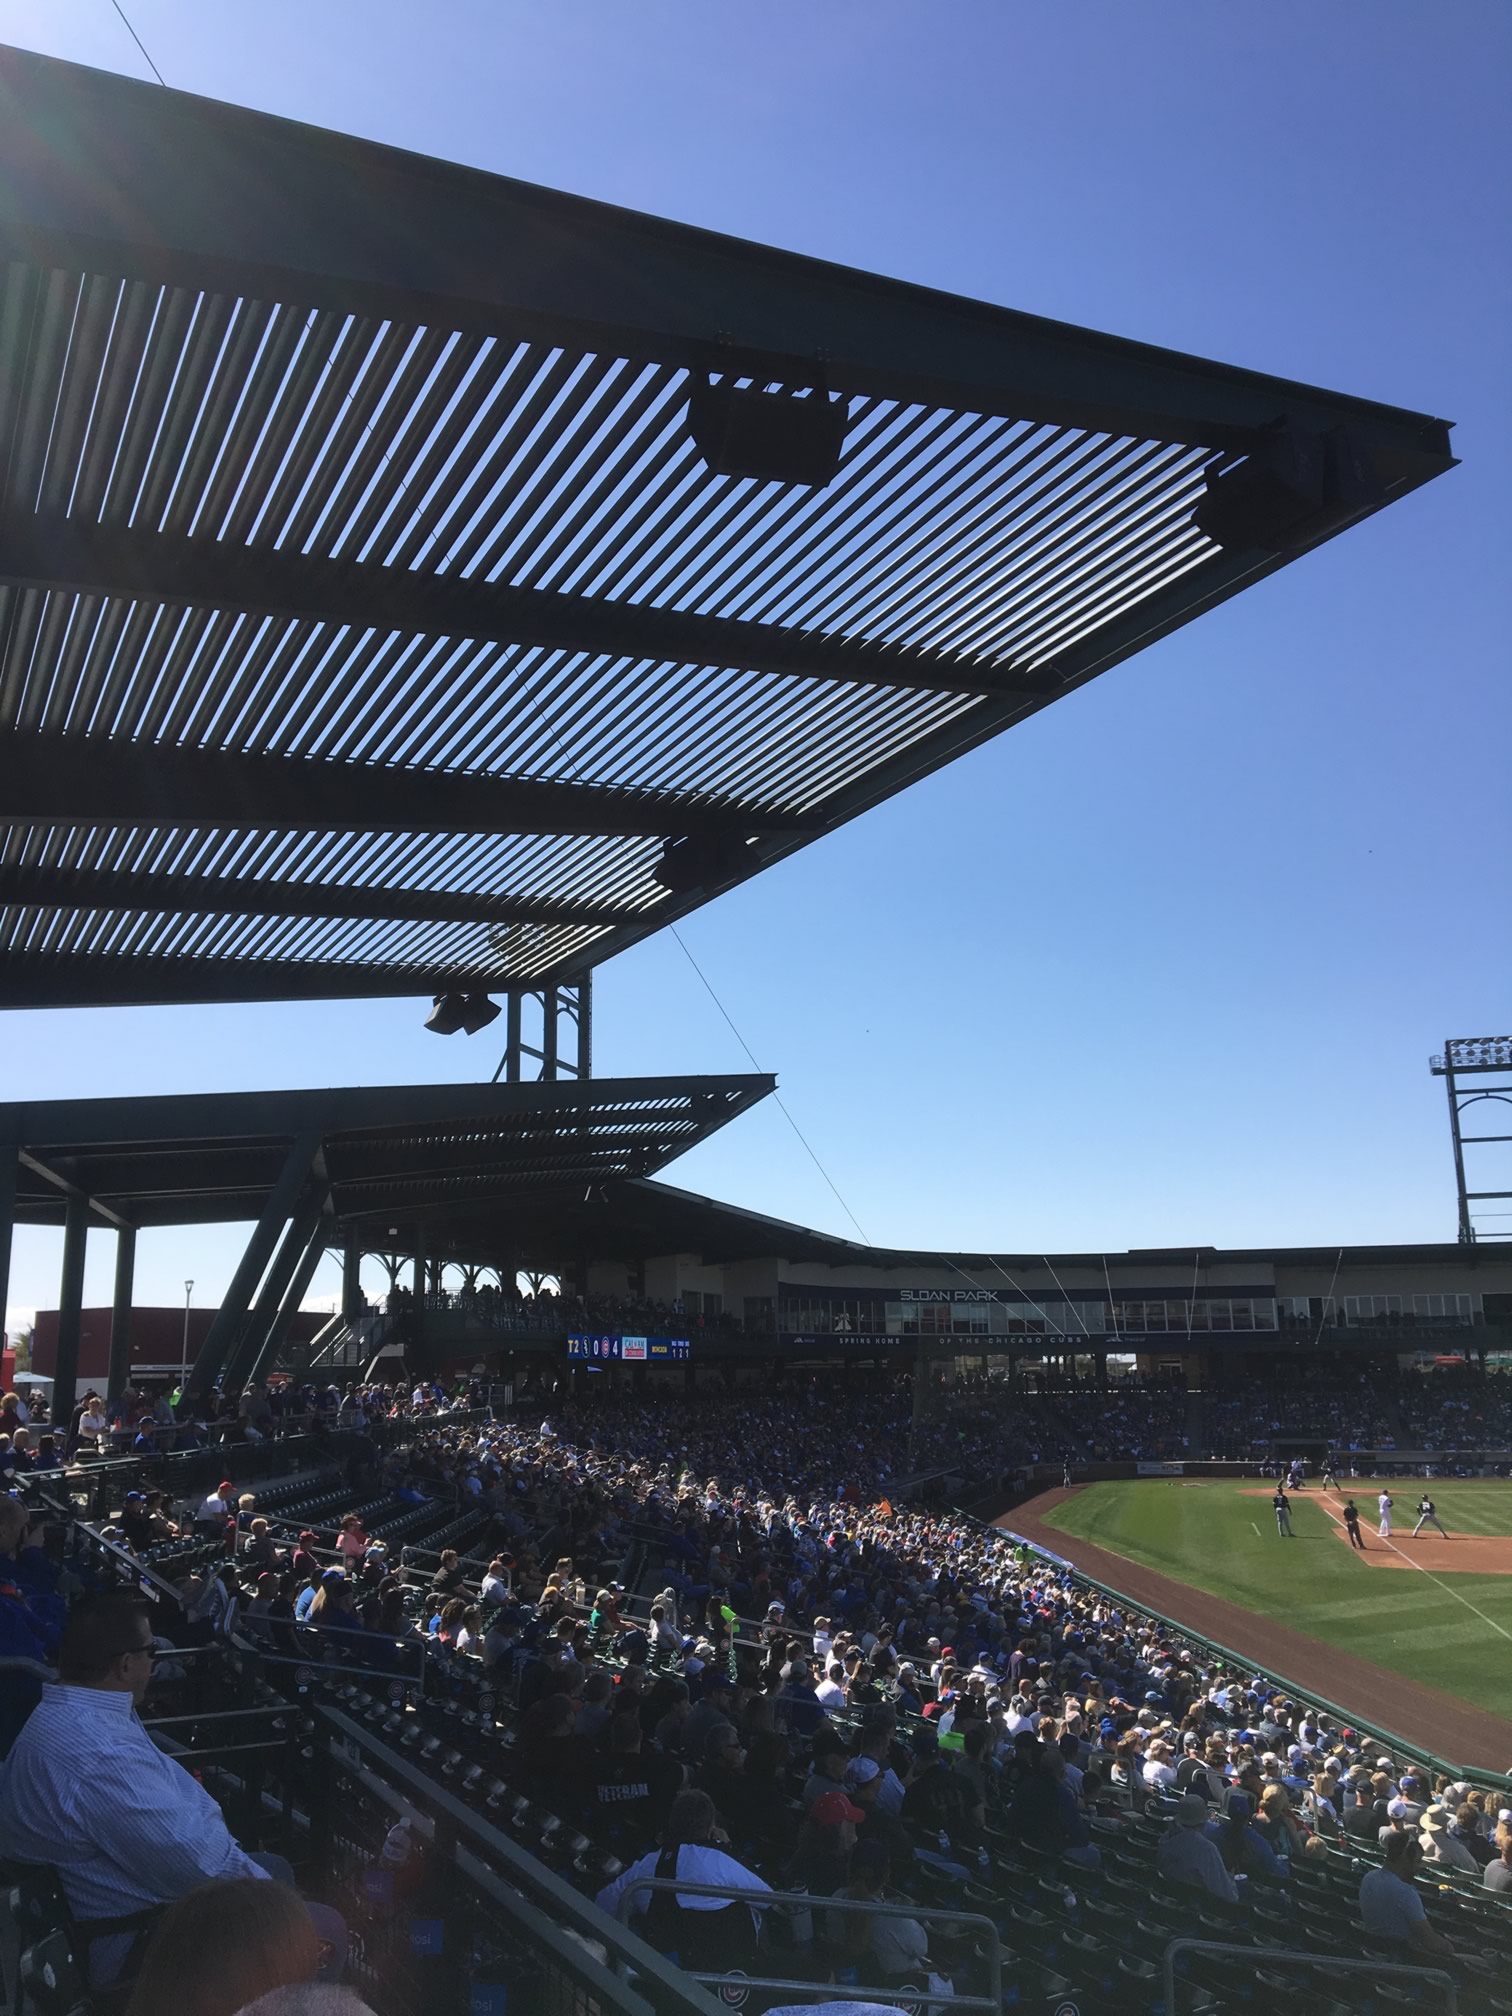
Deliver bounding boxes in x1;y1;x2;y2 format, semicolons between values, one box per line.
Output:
0;1387;1512;2016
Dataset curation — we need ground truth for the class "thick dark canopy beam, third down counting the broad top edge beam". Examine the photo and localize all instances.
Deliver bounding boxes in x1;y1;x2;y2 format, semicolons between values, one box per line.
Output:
0;729;816;839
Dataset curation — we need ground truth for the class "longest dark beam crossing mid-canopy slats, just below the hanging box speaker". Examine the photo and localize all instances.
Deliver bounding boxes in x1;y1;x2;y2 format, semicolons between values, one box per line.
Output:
0;512;1020;701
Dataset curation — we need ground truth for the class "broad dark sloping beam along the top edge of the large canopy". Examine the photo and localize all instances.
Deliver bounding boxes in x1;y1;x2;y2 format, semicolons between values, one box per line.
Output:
0;48;1467;448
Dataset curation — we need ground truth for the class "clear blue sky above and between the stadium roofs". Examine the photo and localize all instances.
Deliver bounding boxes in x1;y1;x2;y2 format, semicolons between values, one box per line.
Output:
0;0;1512;1312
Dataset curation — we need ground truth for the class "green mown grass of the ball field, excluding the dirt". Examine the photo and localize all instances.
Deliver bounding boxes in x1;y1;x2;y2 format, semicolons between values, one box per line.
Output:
1044;1478;1512;1717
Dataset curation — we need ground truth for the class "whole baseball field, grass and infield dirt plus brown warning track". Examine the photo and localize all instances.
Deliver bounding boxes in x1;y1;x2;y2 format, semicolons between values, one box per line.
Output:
1002;1478;1512;1770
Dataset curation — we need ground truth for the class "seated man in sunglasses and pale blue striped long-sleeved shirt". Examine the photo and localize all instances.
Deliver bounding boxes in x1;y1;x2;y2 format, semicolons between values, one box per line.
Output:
0;1595;345;1986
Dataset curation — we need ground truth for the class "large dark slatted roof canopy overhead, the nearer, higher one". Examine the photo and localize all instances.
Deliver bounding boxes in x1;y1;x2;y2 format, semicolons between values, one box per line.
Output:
0;50;1452;1006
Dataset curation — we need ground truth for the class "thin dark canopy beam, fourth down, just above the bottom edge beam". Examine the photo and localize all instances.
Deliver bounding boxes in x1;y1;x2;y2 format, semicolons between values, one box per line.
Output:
0;865;653;929
